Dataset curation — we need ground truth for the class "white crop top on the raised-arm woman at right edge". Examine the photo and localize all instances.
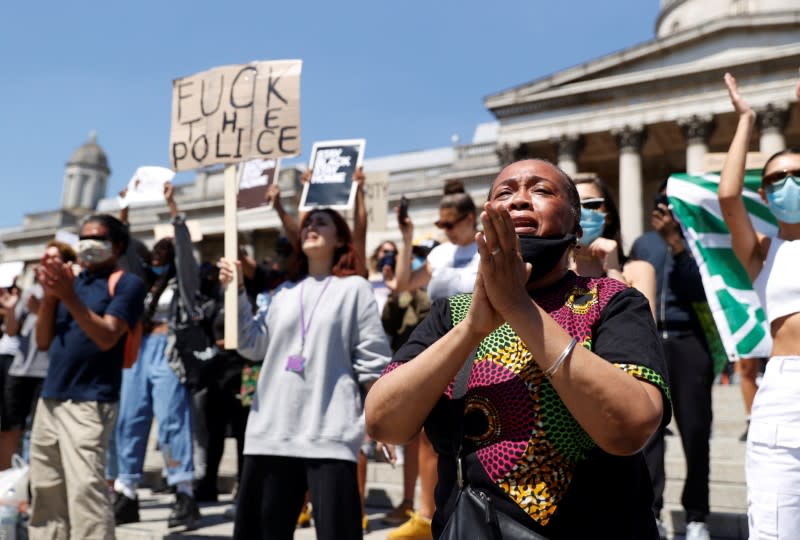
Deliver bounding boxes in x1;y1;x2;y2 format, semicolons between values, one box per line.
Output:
753;238;800;323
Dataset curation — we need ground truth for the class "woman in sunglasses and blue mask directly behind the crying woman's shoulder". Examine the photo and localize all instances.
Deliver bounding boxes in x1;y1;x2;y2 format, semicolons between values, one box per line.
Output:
573;175;656;317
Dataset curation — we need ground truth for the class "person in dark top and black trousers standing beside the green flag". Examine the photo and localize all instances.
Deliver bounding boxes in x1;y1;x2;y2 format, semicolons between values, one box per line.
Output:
630;187;714;540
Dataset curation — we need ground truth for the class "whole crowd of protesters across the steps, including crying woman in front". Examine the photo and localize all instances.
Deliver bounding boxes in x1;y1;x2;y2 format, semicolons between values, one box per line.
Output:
0;71;800;540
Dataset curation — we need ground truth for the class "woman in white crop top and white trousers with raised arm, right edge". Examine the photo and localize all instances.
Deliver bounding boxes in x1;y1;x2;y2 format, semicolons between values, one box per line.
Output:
718;73;800;539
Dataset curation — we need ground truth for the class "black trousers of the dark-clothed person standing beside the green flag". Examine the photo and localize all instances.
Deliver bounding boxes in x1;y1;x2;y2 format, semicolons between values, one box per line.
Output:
644;333;714;522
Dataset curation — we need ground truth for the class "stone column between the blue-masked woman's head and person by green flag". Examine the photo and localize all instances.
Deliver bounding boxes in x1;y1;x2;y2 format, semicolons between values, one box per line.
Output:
611;126;645;252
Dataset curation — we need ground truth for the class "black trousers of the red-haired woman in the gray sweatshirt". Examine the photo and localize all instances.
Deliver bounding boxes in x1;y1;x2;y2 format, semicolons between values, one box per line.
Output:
233;455;363;540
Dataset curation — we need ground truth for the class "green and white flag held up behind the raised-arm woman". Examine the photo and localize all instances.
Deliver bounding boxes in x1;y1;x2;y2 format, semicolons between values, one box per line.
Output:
667;171;777;361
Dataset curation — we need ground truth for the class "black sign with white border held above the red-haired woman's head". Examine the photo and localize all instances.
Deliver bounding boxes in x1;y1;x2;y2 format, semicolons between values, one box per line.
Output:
300;139;366;211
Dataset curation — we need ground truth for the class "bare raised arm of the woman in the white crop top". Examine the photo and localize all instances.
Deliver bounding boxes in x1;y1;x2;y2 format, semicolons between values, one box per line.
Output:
717;73;764;280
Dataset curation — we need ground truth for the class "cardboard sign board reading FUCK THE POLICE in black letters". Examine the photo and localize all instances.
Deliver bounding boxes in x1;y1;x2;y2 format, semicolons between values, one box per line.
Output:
169;60;302;171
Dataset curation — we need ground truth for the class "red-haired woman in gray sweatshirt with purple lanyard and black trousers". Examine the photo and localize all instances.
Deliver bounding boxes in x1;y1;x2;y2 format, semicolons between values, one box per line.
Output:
220;209;391;540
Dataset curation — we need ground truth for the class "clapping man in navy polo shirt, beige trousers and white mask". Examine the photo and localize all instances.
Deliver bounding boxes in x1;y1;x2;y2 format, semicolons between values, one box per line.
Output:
29;214;145;540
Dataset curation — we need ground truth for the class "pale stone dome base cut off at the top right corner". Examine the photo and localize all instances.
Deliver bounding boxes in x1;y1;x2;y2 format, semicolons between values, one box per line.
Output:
656;0;798;37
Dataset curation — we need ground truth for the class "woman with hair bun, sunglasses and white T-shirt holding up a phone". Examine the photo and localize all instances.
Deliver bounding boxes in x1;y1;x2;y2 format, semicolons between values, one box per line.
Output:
388;182;480;540
